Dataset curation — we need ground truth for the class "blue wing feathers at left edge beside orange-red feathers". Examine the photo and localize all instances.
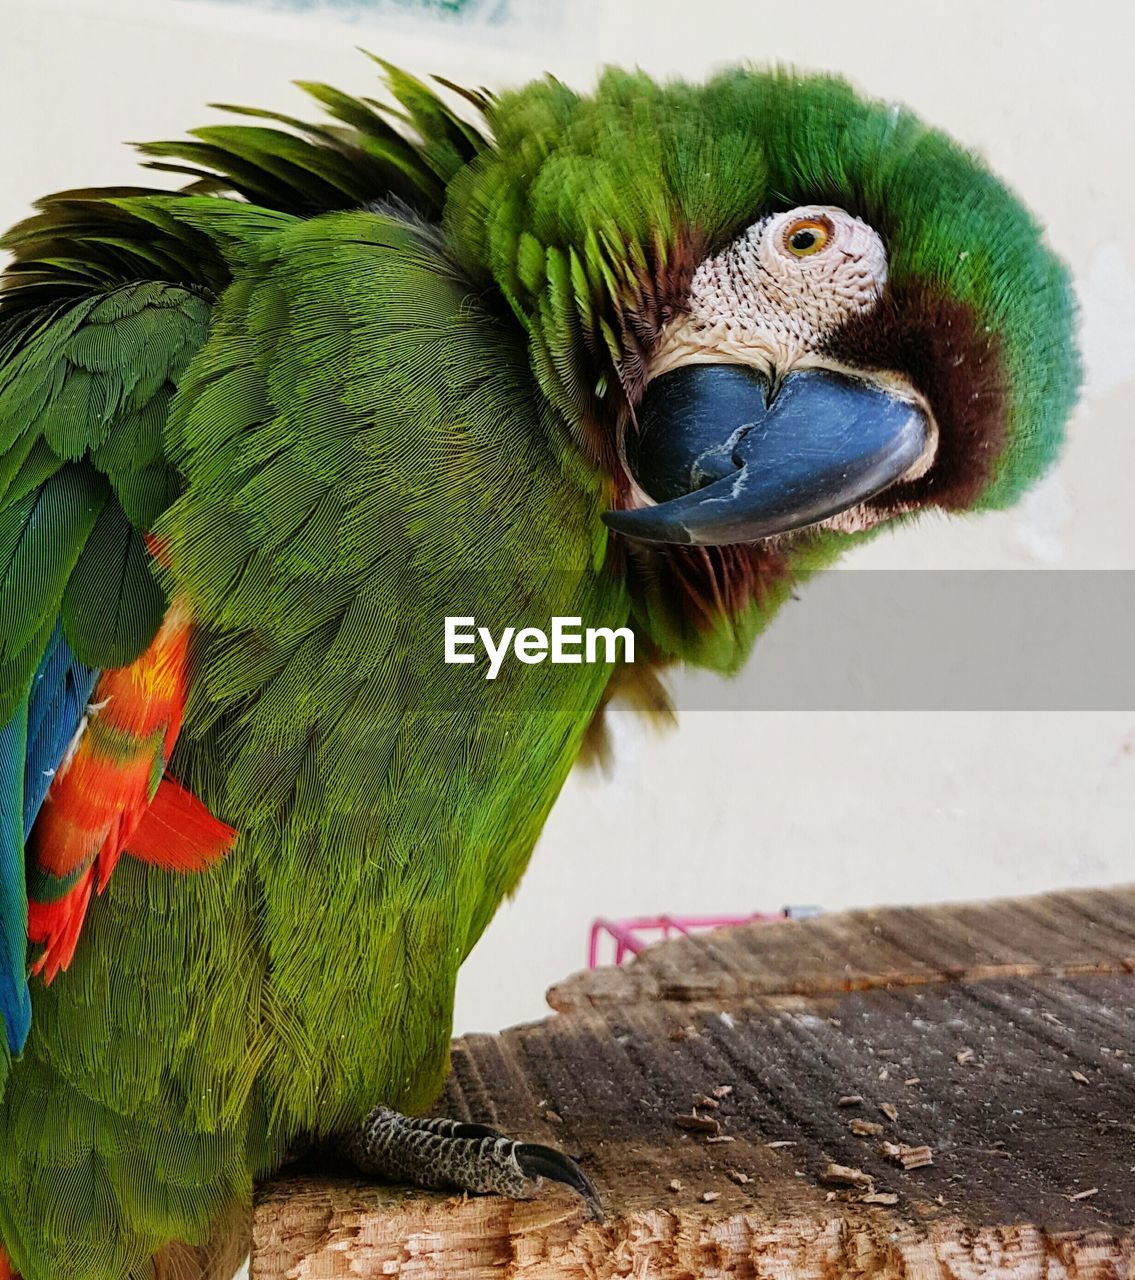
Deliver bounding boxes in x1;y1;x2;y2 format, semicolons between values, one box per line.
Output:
0;623;99;1053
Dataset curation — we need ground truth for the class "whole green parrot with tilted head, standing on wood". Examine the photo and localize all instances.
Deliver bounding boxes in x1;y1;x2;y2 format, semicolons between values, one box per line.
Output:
0;64;1079;1280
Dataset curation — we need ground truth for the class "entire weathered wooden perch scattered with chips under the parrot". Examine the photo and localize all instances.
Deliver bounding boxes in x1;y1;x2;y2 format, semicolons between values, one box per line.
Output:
252;888;1135;1280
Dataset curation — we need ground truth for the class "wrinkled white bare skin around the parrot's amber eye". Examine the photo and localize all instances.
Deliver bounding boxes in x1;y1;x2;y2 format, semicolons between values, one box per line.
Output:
649;205;887;378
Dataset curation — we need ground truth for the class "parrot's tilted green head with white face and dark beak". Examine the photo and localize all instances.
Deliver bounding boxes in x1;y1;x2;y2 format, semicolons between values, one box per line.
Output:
445;70;1079;669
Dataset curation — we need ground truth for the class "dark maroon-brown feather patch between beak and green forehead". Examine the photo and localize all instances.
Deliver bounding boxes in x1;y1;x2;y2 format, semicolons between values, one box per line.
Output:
825;285;1006;512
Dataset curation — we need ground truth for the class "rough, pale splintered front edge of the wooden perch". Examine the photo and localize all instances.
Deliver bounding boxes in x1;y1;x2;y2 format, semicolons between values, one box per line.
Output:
252;1183;1135;1280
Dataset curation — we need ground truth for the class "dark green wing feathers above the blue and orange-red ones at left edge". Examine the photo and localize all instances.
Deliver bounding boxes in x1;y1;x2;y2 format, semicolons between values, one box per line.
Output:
0;282;209;721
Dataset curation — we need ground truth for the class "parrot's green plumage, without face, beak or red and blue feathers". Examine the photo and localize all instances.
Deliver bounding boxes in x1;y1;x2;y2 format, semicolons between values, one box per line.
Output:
0;62;1075;1280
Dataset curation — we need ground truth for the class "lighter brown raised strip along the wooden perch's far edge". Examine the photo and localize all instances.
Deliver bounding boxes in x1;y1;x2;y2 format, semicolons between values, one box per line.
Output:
548;886;1135;1012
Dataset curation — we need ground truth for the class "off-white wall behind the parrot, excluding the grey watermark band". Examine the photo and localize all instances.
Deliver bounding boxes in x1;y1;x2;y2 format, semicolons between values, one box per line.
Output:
0;0;1135;1029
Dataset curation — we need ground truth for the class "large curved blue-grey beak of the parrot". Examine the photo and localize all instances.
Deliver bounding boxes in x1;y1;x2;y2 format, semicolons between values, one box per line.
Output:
603;365;933;545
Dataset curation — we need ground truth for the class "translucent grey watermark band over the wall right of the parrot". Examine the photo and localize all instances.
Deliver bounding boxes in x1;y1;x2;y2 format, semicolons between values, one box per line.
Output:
672;570;1135;712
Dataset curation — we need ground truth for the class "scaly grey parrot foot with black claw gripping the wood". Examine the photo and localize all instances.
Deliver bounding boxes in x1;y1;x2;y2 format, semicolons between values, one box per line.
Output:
340;1107;603;1221
